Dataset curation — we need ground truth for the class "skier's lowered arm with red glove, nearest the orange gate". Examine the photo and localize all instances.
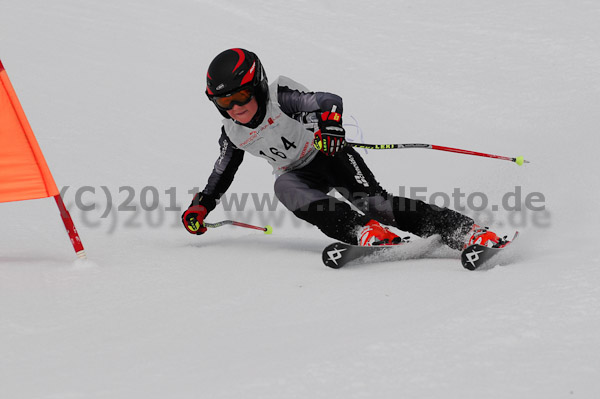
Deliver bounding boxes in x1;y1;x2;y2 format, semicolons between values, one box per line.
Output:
181;129;244;235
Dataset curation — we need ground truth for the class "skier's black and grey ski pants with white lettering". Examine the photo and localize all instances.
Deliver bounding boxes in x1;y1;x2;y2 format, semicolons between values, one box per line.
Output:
275;146;474;249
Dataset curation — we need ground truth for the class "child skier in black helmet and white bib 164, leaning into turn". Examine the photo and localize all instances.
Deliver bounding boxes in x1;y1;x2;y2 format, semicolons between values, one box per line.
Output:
182;48;504;250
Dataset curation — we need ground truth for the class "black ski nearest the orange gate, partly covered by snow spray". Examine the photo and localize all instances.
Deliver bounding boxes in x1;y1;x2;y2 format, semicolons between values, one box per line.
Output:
322;235;457;269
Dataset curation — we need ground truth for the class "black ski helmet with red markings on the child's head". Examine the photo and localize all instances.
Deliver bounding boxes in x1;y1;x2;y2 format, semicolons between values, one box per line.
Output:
206;48;269;118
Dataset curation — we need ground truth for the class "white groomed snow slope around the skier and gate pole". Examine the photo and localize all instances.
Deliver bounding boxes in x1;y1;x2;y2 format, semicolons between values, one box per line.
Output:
0;0;600;399
